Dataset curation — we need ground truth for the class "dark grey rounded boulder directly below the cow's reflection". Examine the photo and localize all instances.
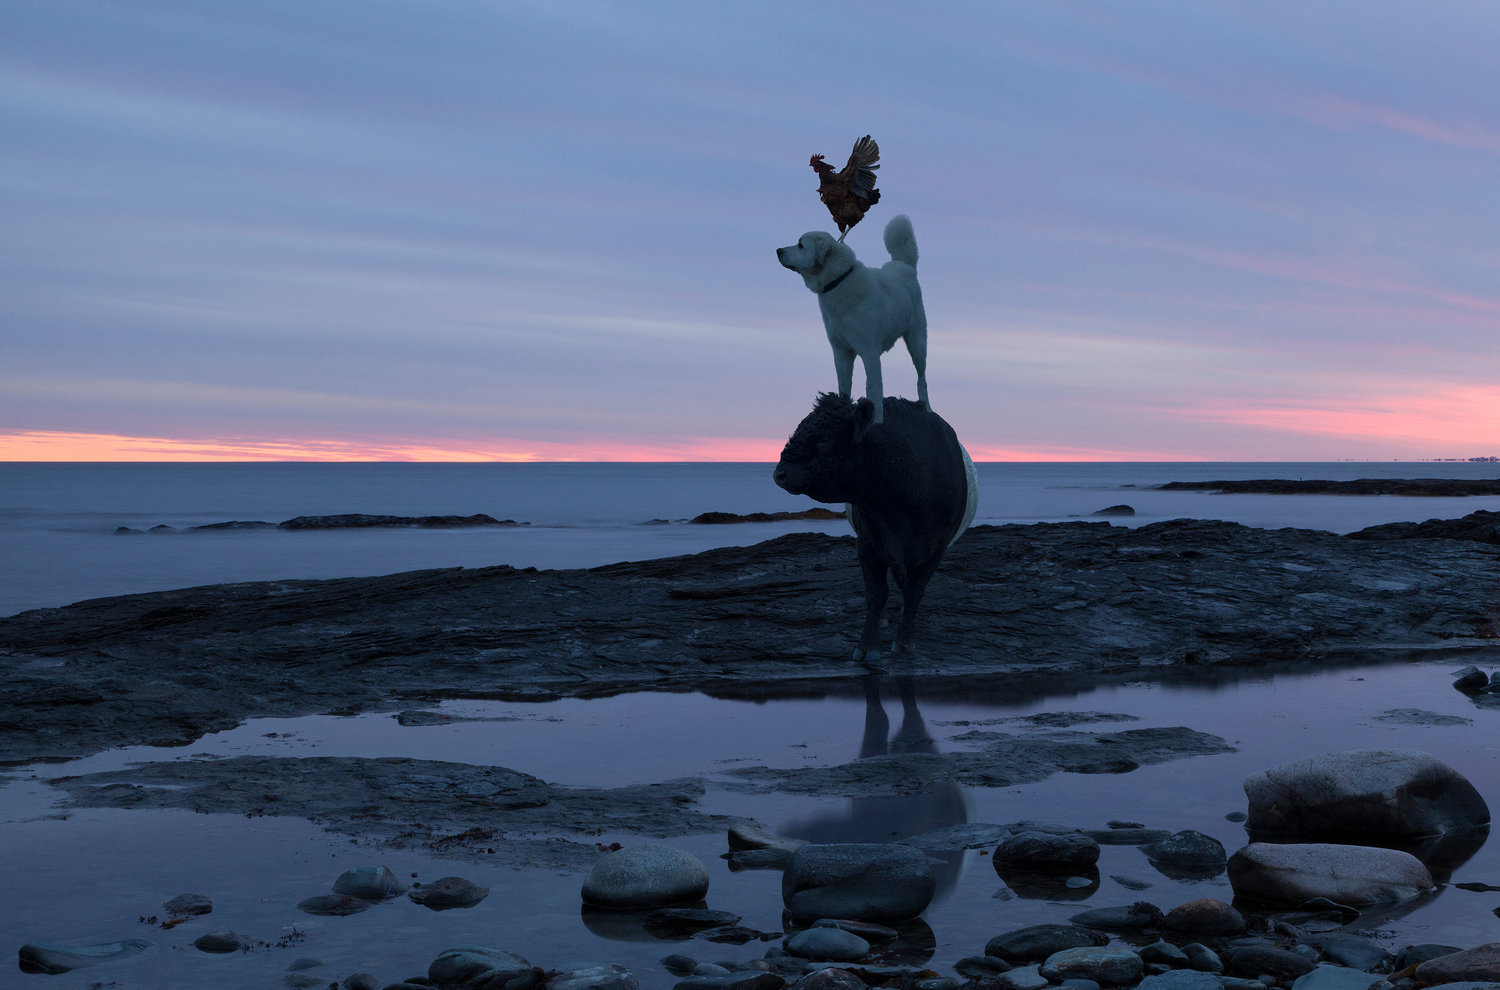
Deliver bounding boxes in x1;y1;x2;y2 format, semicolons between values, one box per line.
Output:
782;843;938;924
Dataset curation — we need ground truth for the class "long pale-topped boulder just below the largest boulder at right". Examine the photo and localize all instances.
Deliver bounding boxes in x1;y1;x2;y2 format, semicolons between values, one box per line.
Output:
1229;842;1433;908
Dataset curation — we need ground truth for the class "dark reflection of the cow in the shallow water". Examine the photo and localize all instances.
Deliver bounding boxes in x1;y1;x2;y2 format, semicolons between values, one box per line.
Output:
779;674;972;893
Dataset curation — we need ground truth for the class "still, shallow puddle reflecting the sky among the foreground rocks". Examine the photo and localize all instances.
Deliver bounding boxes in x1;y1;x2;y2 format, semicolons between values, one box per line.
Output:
0;656;1500;989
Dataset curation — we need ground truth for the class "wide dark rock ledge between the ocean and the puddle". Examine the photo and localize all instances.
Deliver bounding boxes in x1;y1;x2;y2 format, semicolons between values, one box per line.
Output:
0;521;1500;762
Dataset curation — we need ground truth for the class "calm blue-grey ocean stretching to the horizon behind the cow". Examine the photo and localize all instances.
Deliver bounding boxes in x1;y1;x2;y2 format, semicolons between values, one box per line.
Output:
0;462;1500;615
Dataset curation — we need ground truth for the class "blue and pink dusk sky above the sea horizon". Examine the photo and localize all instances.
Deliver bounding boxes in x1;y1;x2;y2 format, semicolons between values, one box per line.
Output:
0;0;1500;461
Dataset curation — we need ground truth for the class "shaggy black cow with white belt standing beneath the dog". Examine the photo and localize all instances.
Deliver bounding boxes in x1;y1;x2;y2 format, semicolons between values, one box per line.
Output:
773;393;978;662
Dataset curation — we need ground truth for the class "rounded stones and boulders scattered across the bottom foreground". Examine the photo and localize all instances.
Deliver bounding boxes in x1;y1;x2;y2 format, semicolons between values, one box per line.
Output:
21;750;1500;990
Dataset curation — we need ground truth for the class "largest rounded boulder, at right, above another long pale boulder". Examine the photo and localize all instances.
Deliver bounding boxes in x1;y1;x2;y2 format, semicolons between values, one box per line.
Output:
1245;750;1490;839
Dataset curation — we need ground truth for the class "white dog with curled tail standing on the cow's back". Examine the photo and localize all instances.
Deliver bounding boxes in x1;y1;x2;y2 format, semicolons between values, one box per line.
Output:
776;216;933;423
